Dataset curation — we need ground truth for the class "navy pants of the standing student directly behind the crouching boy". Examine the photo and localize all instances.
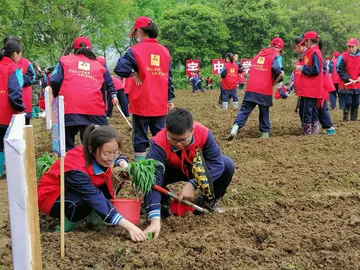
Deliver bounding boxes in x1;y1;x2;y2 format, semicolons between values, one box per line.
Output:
132;114;166;153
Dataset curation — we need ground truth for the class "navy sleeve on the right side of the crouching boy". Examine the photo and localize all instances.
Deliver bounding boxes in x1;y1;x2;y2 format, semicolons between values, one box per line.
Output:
202;130;225;181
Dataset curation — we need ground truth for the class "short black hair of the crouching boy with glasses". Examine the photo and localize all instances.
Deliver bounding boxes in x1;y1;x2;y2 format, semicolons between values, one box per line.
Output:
166;108;194;135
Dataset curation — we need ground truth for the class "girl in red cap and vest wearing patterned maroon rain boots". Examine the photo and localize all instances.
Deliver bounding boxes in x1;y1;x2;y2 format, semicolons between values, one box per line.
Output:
294;31;324;135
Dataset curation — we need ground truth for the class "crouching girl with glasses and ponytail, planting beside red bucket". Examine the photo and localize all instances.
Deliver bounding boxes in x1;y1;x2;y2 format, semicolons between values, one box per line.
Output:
38;125;146;241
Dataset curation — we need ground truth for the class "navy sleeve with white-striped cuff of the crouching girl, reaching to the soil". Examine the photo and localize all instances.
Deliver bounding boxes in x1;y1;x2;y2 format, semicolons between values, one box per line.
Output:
65;170;122;225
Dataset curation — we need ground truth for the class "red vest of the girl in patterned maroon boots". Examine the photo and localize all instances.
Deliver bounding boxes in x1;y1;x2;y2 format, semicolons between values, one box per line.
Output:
296;46;324;98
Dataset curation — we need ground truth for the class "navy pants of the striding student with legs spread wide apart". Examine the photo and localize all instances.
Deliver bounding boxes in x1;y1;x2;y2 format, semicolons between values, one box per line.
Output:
234;100;271;132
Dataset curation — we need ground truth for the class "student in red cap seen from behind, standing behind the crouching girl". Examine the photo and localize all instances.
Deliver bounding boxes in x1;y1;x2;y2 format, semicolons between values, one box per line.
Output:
50;37;118;151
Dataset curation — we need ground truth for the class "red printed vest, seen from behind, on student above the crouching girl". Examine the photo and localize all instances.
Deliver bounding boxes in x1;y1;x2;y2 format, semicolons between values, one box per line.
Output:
59;54;106;115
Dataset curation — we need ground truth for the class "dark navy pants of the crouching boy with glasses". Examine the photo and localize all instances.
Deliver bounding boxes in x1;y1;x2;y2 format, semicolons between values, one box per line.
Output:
162;155;235;199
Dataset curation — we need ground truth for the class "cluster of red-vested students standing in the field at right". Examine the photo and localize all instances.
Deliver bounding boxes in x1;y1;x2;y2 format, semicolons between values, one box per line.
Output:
226;31;360;140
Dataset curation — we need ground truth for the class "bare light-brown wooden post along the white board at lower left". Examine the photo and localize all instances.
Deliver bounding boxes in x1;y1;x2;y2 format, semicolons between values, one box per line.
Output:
24;126;42;270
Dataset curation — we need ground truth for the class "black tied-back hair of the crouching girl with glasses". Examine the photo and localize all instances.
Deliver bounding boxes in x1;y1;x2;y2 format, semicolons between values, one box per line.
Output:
83;125;121;165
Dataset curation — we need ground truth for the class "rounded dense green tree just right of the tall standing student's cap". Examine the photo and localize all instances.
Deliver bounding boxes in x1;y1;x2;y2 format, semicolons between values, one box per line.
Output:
159;4;229;65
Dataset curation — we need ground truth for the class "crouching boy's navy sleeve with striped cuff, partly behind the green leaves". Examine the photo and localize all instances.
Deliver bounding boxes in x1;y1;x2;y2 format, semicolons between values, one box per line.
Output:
144;142;167;219
